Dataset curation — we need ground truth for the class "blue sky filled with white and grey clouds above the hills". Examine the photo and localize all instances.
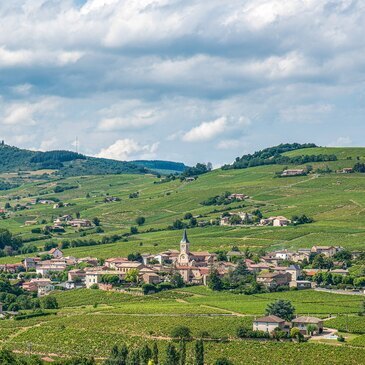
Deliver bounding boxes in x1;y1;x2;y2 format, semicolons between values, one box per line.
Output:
0;0;365;166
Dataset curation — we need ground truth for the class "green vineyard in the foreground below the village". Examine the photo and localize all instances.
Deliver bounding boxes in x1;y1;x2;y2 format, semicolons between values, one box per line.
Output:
0;287;365;365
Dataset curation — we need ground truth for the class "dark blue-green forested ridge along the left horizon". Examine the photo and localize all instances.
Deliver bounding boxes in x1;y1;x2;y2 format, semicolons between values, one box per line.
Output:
0;144;185;176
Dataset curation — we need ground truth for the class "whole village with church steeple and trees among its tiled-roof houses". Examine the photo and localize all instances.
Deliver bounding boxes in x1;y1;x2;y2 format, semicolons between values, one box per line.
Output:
0;229;356;296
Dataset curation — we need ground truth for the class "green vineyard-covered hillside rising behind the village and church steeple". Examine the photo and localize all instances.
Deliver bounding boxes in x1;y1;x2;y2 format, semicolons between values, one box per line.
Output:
0;144;365;262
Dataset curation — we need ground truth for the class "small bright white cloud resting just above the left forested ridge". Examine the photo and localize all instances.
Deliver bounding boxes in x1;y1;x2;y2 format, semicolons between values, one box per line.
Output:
96;138;159;161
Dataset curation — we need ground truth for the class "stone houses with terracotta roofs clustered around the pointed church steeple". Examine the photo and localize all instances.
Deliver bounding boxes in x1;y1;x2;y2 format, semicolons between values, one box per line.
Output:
0;230;348;295
